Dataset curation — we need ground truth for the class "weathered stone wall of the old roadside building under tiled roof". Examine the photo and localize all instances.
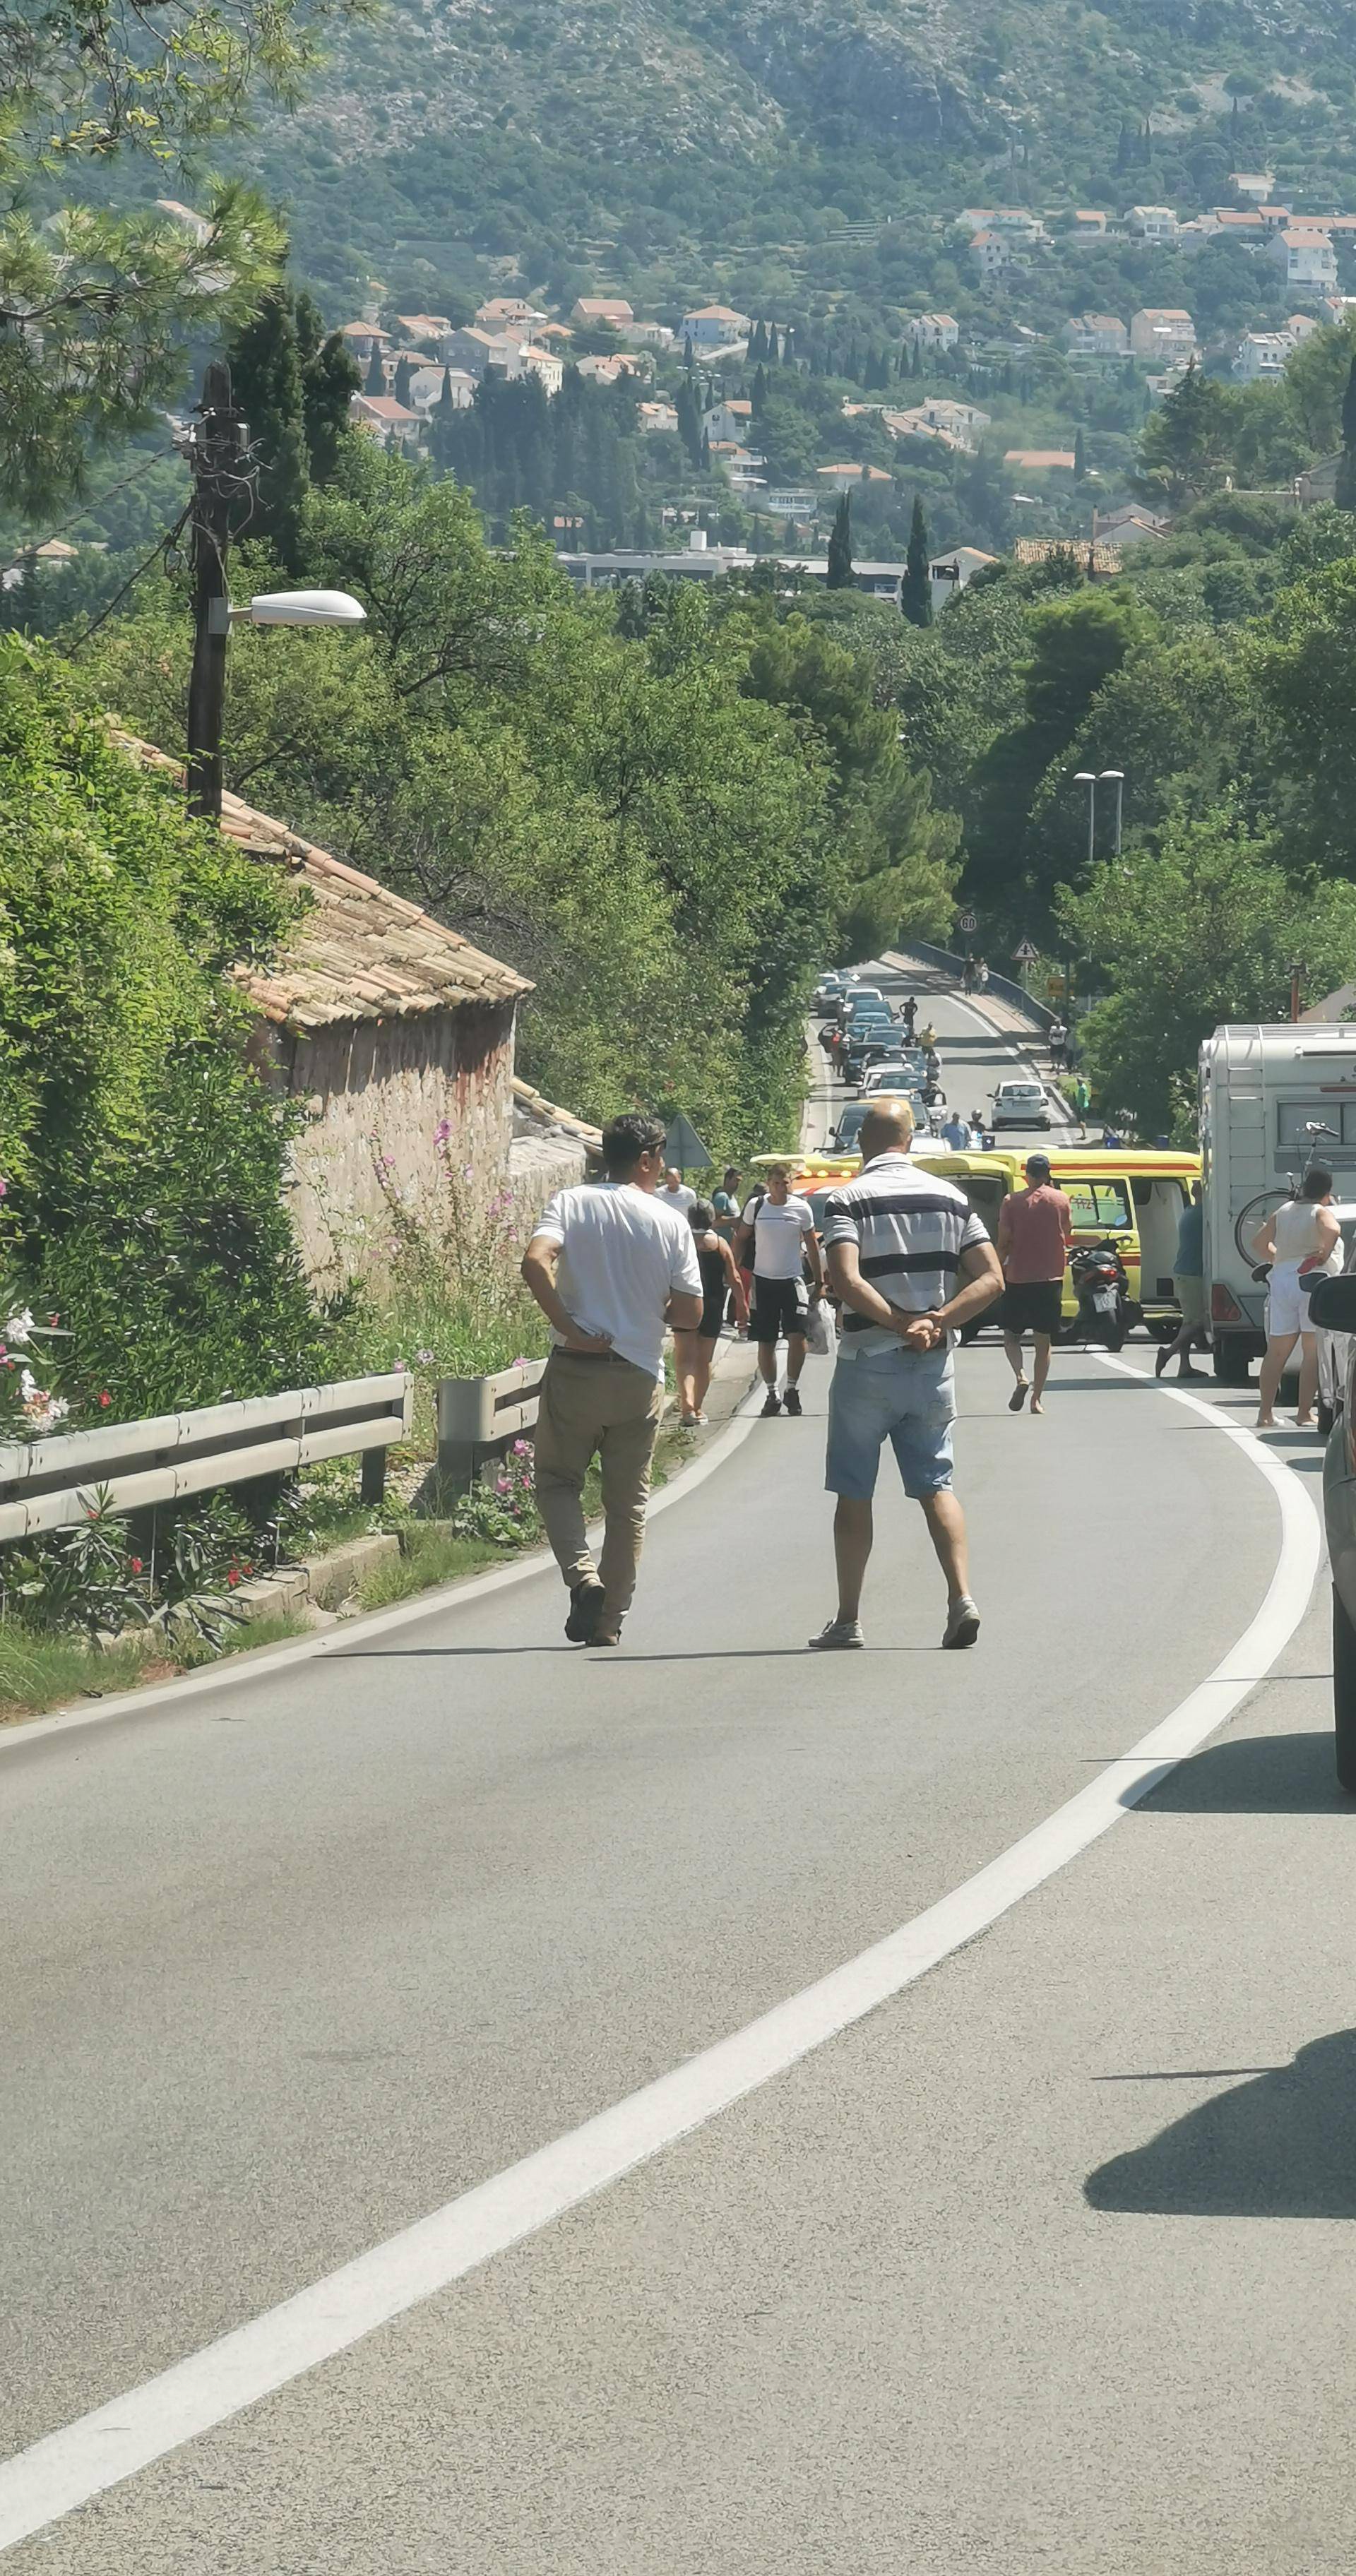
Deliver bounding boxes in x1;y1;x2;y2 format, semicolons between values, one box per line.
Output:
268;1002;513;1288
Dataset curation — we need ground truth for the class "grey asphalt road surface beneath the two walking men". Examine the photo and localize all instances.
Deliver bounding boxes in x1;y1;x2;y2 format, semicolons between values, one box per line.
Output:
0;979;1356;2576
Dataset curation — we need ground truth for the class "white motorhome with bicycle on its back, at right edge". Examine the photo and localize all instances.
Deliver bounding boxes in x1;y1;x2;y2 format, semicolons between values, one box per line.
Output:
1201;1020;1356;1386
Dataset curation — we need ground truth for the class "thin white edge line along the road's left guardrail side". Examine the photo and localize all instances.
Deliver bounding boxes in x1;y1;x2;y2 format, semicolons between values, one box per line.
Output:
0;1378;763;1757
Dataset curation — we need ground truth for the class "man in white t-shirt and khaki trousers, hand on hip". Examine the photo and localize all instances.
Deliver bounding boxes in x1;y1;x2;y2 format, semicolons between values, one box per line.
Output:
523;1116;701;1646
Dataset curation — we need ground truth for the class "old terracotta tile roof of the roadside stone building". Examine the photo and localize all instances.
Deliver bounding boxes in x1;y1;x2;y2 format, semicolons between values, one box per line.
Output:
114;732;531;1028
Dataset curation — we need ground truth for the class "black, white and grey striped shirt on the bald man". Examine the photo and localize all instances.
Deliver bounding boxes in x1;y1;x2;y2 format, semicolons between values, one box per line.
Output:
820;1154;987;1355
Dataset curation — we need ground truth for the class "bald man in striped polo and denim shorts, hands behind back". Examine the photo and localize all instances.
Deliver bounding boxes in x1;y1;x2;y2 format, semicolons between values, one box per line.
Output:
809;1102;1003;1646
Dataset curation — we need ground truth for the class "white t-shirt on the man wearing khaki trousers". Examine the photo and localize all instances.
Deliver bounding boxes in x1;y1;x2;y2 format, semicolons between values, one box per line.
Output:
531;1180;701;1378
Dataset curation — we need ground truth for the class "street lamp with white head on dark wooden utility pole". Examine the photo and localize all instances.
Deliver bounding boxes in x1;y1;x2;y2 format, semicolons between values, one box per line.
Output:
188;361;366;822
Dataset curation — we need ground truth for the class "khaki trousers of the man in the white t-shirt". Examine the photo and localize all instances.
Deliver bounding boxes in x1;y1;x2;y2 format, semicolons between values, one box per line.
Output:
536;1350;665;1618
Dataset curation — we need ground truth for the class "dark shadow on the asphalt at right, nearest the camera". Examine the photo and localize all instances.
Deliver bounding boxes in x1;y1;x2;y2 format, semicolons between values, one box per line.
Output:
1083;2030;1356;2218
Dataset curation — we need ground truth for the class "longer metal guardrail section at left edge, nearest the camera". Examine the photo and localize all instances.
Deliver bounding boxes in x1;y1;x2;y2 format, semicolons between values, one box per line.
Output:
0;1368;415;1543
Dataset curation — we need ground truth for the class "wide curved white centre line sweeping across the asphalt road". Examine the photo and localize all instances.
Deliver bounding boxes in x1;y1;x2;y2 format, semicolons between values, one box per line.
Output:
0;1357;1320;2551
